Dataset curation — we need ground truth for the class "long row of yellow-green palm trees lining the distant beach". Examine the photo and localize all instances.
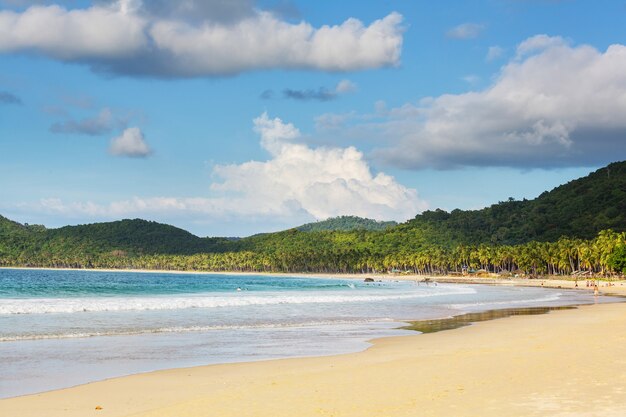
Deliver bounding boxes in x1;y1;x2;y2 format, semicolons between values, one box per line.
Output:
6;230;626;275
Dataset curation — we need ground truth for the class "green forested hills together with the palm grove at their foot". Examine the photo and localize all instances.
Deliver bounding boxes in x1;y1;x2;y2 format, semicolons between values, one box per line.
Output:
0;162;626;275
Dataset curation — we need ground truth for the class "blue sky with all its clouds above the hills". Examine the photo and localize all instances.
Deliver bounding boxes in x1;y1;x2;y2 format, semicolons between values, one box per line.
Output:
0;0;626;236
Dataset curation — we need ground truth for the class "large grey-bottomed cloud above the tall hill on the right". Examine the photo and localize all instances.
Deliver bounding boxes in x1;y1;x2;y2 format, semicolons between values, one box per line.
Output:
316;35;626;169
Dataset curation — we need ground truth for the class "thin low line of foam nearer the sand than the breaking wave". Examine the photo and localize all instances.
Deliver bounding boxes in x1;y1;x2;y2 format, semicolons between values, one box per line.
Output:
0;318;395;342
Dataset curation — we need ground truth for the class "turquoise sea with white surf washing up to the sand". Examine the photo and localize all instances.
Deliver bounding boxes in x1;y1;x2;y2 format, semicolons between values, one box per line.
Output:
0;269;608;398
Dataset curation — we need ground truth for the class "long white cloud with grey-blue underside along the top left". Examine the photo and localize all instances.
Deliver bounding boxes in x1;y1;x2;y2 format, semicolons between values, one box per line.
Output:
0;0;403;77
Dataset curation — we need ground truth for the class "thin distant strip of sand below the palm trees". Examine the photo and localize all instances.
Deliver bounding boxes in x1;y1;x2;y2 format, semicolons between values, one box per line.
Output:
0;266;626;296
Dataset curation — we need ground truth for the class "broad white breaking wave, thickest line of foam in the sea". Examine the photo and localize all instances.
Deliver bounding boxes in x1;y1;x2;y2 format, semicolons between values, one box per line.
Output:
0;286;475;315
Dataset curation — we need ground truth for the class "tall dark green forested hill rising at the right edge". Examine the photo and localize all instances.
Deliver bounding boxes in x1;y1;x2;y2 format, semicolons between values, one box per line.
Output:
402;162;626;244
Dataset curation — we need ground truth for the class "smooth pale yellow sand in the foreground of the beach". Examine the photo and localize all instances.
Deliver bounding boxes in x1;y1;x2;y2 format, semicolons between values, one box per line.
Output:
0;304;626;417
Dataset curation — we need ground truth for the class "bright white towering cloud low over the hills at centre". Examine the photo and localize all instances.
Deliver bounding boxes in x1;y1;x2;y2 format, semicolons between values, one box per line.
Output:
212;114;426;220
